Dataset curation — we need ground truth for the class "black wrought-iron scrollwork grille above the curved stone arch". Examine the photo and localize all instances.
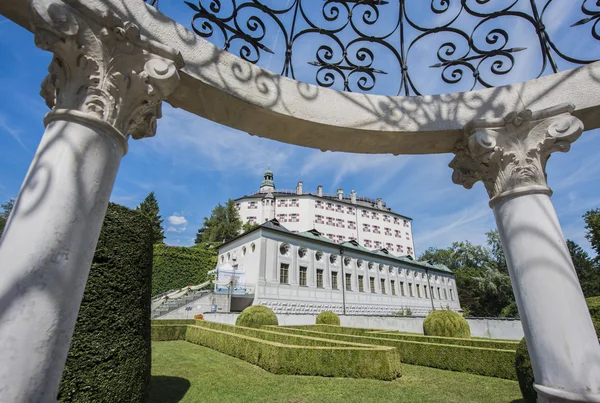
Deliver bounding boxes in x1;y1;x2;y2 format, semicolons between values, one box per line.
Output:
148;0;600;96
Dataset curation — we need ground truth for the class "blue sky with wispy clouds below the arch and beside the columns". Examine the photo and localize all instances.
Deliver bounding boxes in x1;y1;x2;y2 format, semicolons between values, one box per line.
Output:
0;0;600;254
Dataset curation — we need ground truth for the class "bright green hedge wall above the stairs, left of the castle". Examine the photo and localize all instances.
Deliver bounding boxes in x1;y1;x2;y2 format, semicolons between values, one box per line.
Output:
152;244;218;295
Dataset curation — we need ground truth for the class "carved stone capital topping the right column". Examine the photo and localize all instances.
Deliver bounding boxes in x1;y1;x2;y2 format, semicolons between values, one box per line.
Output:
449;104;583;206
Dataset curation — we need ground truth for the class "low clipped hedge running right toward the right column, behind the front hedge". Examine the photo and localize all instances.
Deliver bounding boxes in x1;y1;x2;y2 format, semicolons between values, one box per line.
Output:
269;326;517;380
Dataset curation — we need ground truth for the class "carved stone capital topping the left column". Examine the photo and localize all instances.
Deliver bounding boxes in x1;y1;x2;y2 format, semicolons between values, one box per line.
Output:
31;0;183;150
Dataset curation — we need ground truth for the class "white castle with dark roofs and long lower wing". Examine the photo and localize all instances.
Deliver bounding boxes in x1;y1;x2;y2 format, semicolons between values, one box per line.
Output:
212;169;460;315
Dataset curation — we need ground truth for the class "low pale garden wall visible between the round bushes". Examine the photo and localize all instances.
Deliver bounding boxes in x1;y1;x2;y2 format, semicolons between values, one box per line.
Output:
190;313;524;340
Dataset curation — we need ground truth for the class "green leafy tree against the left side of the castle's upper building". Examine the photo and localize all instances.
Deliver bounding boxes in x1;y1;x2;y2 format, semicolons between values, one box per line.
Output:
194;199;242;243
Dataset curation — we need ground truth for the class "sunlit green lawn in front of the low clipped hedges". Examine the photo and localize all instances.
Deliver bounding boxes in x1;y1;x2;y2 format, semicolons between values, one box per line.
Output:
150;341;521;403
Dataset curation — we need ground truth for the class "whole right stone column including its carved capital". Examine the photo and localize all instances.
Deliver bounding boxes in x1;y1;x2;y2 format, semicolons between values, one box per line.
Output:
450;105;600;402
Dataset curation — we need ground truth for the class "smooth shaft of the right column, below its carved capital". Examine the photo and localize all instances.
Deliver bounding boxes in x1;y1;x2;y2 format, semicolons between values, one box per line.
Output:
493;194;600;402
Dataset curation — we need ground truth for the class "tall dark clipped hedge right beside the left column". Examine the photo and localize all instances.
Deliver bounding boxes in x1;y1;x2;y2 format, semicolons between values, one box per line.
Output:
58;203;152;403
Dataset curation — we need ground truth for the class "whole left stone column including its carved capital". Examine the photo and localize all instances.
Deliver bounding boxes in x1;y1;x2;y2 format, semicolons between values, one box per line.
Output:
0;0;181;402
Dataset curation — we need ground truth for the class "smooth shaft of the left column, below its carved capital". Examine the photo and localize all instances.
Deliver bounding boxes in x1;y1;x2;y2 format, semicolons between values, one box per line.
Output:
0;120;124;402
